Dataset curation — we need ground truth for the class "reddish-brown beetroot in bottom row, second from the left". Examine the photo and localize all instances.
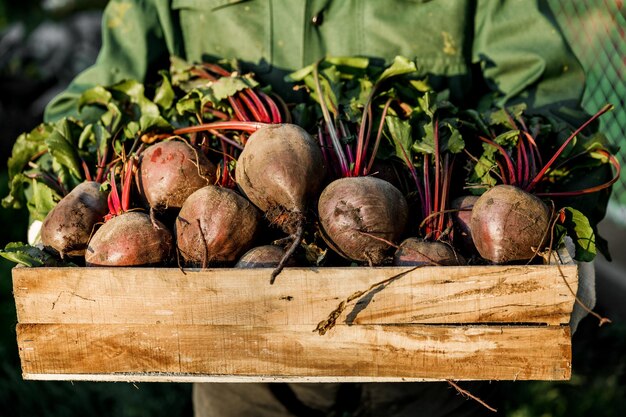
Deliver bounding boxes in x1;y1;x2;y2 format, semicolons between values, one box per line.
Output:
85;211;174;266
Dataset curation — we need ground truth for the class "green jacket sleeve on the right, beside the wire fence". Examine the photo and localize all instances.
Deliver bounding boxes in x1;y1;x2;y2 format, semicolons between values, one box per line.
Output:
472;0;585;121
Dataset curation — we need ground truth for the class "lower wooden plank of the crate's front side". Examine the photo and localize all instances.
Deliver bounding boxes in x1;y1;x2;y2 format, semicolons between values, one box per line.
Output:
17;324;571;380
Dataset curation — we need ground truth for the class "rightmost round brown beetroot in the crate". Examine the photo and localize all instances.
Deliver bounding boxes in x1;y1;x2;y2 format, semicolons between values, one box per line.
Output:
470;185;550;264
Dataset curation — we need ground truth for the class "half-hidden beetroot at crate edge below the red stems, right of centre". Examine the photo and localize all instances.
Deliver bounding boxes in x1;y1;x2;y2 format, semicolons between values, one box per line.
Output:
393;237;465;266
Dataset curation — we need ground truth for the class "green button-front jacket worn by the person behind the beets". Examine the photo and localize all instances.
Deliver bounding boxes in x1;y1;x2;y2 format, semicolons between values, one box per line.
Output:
45;0;584;121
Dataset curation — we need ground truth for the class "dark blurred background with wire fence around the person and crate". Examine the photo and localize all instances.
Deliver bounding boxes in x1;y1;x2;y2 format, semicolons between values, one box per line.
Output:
0;0;626;417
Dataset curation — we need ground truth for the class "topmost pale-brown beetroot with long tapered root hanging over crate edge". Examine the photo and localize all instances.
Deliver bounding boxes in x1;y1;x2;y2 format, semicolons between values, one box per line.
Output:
235;123;326;283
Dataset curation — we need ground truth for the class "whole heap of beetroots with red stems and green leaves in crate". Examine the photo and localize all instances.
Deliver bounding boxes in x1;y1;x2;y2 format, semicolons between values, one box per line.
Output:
7;57;619;283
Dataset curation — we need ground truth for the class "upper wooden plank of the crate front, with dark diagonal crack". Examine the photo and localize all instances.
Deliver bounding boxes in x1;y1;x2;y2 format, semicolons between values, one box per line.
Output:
13;265;578;326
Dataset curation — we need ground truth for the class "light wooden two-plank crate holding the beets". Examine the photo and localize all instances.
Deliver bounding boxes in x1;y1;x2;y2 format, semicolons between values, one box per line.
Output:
13;264;578;382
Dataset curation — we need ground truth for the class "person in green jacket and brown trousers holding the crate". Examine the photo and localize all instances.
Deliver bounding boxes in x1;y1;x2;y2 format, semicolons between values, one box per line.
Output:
45;0;595;417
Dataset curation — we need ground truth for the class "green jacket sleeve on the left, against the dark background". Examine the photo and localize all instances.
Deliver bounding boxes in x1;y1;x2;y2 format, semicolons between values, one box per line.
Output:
44;0;174;122
